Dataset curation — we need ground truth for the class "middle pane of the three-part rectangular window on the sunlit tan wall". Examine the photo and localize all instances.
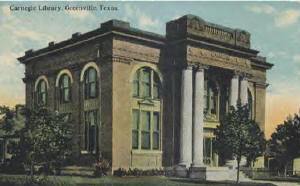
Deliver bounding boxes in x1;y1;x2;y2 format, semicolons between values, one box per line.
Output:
141;111;150;149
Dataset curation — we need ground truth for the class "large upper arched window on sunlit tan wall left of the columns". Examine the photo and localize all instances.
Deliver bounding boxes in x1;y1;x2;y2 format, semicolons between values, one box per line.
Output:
132;67;160;99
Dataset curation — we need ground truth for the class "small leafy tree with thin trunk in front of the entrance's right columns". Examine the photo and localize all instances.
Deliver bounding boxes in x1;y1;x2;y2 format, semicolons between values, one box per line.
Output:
215;103;265;183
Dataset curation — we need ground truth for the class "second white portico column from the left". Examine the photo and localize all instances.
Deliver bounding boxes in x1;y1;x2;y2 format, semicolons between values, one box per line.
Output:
192;68;204;167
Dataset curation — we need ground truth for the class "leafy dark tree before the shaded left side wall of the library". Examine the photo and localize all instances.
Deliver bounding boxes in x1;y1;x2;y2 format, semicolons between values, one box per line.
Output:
18;108;72;177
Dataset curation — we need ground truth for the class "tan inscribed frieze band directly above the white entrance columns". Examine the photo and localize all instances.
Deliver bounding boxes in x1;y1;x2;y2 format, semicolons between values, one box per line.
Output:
187;46;251;72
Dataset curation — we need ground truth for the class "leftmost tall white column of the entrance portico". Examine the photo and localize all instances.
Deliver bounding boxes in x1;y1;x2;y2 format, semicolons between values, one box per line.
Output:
179;67;193;167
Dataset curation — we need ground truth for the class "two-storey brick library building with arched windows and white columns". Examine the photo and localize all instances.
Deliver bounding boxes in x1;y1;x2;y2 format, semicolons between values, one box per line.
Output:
18;15;272;176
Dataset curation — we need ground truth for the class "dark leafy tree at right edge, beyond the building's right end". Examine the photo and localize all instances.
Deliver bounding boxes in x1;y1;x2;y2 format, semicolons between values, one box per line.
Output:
269;114;300;176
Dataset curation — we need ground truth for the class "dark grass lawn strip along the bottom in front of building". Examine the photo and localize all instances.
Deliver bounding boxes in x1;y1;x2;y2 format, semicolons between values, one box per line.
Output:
0;174;273;186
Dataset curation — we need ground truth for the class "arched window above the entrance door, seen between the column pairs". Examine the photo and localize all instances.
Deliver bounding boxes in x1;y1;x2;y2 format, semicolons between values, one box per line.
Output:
204;80;219;119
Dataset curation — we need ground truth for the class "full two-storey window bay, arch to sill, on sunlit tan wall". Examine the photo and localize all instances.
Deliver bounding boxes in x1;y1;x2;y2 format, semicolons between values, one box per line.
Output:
132;67;161;150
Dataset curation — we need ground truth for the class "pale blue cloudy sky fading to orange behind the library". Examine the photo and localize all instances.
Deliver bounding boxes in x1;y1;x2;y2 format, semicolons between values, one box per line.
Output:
0;2;300;136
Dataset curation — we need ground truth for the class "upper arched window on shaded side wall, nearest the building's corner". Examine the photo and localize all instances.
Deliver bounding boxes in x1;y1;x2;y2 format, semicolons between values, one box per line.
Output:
84;67;98;99
